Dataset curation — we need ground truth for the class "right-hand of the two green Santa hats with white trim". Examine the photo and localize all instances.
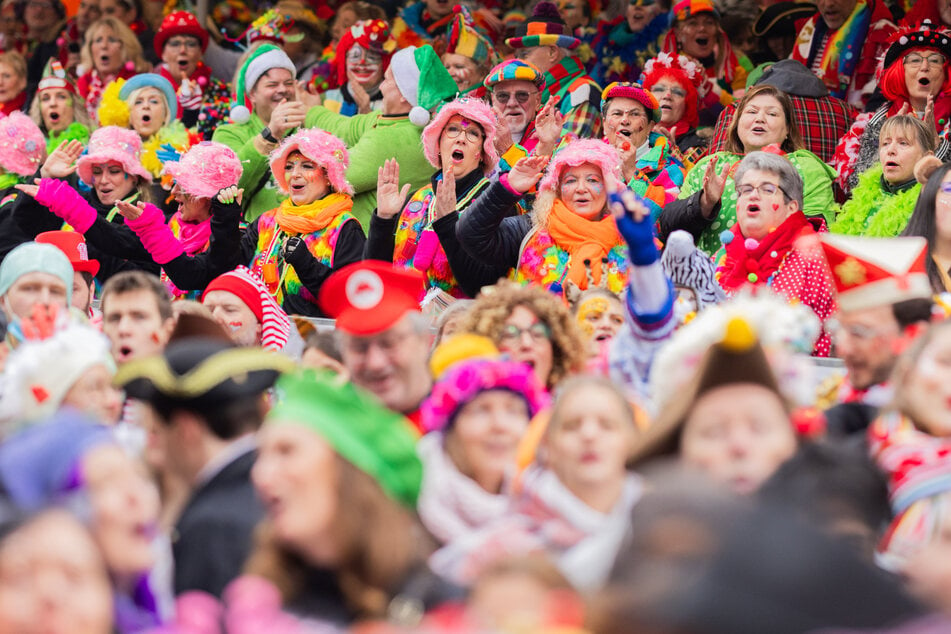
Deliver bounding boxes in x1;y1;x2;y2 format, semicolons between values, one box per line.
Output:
390;44;459;128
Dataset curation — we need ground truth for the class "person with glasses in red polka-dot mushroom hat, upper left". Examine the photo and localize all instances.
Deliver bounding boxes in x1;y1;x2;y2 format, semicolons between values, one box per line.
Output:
155;11;231;139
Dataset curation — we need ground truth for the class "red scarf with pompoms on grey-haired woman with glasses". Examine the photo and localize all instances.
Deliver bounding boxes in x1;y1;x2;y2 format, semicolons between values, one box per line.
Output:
717;211;813;292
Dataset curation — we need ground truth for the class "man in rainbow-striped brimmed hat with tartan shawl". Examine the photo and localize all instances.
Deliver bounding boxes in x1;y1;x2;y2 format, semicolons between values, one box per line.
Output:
505;1;601;139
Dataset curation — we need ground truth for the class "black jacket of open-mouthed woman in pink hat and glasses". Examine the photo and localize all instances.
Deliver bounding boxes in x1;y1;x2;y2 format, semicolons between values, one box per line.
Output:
364;169;508;297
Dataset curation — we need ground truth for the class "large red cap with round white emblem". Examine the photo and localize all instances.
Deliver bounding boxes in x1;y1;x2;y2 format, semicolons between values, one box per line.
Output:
317;260;425;336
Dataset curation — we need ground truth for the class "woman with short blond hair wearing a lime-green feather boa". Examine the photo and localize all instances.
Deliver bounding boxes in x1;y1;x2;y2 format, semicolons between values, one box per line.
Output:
829;115;938;238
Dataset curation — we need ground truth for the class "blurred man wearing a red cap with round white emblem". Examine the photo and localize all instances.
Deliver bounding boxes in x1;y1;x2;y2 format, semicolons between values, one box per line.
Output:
318;260;432;426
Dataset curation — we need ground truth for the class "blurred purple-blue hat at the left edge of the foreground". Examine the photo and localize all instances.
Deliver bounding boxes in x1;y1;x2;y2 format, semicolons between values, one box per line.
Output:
0;412;116;510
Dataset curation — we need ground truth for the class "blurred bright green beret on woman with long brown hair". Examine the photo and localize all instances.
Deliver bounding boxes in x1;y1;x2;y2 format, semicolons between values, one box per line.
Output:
265;370;423;509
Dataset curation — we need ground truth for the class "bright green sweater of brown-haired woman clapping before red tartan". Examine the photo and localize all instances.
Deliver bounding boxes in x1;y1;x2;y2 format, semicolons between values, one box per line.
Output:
679;150;837;254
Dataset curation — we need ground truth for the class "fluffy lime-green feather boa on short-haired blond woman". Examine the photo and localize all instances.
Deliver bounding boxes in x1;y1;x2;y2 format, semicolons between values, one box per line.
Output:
829;163;921;238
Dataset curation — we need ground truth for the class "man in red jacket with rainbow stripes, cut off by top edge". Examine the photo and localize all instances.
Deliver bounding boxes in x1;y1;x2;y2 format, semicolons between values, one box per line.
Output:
792;0;898;109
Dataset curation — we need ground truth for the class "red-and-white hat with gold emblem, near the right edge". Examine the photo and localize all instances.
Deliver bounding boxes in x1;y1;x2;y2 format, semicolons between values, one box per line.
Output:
820;233;933;311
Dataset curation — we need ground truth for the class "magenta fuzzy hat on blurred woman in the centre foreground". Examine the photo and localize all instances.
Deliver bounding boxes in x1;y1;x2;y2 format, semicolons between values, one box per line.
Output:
420;359;549;431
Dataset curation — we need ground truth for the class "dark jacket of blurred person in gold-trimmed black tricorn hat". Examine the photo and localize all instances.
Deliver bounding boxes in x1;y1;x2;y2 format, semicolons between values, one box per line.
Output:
172;450;264;597
